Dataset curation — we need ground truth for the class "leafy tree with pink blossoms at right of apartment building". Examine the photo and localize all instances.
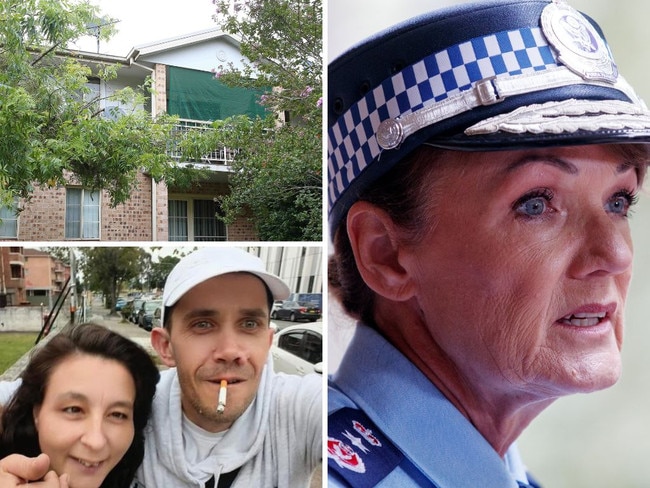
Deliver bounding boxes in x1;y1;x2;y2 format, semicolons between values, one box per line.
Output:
205;0;322;241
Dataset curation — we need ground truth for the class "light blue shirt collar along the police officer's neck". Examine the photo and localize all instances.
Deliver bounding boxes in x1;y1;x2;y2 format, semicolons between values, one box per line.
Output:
331;324;526;488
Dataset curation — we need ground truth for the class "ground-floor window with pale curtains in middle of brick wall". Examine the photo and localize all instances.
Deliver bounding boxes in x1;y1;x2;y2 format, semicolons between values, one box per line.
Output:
65;188;99;239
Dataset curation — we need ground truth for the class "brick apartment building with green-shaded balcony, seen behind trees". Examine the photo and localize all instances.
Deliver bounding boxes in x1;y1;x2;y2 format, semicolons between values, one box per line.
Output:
0;29;263;242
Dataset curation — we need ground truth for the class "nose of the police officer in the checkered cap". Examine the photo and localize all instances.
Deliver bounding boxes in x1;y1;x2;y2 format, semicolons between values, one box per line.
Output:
573;211;633;278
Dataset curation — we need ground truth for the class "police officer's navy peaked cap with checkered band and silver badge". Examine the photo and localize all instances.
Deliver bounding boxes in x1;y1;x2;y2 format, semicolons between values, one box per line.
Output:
328;0;650;232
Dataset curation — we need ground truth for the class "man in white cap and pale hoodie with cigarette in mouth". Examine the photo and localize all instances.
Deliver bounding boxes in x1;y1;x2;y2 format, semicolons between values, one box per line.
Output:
135;248;322;488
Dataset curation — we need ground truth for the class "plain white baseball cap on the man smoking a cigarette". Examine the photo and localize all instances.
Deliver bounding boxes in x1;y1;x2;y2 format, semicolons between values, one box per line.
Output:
163;247;289;322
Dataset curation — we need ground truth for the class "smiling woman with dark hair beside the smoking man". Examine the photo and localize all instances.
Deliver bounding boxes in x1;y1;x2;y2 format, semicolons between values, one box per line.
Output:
0;324;159;488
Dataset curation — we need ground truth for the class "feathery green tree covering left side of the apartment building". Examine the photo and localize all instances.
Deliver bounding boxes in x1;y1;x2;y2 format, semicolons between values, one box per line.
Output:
0;0;197;205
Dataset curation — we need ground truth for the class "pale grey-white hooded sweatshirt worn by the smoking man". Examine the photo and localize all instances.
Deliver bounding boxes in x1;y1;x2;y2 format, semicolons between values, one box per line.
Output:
133;360;322;488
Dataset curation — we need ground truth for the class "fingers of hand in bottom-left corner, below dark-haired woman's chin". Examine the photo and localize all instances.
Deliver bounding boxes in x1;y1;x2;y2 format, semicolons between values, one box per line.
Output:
0;454;68;488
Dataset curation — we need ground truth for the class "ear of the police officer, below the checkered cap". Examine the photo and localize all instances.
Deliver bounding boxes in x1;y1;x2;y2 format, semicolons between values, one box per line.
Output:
347;201;413;301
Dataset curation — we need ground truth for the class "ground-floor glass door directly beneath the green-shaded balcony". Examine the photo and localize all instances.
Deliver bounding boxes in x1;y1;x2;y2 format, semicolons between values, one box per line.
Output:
168;198;228;241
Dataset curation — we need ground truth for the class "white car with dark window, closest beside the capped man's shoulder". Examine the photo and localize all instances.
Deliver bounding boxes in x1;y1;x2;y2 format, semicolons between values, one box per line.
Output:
271;322;323;376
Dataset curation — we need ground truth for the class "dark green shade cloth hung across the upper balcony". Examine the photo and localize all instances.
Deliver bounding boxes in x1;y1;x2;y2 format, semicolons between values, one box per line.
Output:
167;66;267;121
